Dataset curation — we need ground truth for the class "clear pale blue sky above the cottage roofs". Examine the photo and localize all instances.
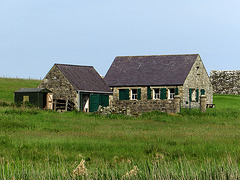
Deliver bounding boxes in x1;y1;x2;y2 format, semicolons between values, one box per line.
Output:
0;0;240;79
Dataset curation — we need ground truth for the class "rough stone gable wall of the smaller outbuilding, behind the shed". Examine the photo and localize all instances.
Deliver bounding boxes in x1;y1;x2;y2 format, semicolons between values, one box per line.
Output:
38;65;78;107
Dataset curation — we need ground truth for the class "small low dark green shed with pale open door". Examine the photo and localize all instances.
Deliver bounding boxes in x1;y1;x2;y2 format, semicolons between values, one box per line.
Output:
14;88;53;109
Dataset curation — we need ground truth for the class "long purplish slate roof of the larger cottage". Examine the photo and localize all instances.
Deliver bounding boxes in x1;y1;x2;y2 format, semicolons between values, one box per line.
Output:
104;54;198;87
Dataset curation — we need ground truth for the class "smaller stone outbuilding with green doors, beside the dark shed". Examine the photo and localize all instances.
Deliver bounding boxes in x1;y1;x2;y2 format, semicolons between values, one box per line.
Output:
38;64;112;112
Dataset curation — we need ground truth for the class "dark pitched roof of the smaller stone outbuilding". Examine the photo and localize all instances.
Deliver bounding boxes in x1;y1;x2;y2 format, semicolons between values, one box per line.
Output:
55;64;112;92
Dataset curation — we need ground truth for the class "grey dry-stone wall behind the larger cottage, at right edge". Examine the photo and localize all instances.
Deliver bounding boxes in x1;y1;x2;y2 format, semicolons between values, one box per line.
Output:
210;70;240;95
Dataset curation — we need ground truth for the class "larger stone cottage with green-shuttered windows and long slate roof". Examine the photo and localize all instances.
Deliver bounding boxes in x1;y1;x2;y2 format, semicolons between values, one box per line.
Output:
104;54;213;112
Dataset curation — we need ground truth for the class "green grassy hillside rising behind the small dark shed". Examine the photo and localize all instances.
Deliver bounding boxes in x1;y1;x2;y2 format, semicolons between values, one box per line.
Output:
0;78;41;102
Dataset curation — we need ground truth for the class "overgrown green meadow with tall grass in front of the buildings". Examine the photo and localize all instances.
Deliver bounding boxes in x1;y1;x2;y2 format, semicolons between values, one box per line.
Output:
0;78;240;179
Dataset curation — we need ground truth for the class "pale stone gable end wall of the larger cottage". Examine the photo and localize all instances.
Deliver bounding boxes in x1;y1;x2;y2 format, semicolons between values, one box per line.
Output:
182;56;213;108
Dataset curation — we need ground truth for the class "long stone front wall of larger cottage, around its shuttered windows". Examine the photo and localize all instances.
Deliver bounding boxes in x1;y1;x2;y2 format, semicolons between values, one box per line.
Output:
109;86;182;114
